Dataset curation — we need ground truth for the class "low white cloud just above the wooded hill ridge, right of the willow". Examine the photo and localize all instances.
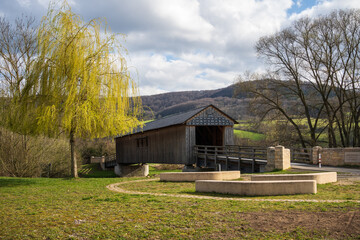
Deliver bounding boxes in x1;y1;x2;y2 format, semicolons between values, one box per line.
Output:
132;54;236;95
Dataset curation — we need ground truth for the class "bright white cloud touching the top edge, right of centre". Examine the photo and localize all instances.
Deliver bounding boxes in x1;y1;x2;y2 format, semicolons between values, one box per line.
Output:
203;0;292;44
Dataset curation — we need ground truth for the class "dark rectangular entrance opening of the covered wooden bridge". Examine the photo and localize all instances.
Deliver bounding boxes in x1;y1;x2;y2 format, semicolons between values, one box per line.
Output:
196;126;225;146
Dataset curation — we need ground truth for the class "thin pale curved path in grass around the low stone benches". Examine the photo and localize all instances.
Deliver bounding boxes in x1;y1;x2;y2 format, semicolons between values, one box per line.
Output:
106;178;360;203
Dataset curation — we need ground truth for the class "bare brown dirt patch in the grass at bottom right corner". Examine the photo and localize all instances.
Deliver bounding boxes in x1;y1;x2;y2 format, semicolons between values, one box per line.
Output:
239;211;360;239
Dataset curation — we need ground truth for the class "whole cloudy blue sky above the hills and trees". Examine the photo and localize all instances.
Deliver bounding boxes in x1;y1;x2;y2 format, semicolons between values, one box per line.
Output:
0;0;360;95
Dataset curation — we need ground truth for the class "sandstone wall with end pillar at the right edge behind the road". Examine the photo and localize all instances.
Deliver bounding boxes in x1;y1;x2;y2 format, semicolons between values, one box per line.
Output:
312;147;360;166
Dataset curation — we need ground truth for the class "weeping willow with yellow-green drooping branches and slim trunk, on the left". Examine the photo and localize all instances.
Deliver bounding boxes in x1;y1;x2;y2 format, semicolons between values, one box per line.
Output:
21;1;141;177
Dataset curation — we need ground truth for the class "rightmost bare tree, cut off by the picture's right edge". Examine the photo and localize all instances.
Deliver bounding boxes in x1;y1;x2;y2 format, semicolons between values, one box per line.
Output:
332;10;360;146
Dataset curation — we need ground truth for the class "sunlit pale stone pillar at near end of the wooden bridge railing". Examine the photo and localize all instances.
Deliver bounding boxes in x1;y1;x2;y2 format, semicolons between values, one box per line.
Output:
265;145;290;172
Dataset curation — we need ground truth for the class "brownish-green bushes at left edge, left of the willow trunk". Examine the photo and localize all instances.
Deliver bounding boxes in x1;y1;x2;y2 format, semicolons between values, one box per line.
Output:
0;128;70;177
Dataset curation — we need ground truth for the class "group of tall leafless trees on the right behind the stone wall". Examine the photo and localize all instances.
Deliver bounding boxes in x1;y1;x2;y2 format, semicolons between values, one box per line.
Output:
236;9;360;147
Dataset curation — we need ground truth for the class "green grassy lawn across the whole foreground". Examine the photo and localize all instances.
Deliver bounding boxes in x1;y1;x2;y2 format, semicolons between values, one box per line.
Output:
0;166;360;239
